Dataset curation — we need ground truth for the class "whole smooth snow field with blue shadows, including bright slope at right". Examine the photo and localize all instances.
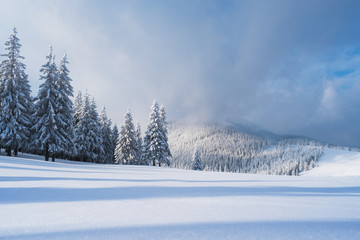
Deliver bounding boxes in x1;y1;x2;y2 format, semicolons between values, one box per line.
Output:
0;150;360;240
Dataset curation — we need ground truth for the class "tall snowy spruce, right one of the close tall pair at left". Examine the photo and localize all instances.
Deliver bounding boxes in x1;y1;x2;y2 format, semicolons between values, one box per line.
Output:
55;55;75;157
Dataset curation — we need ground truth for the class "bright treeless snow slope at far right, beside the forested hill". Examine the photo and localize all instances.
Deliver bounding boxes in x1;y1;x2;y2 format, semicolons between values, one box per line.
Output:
303;148;360;177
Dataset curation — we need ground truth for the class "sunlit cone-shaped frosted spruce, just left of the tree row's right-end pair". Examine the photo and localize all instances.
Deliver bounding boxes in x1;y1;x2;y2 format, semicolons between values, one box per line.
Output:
115;109;138;165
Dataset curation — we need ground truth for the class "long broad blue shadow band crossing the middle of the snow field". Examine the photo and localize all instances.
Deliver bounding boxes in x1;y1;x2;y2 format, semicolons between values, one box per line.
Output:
0;185;360;204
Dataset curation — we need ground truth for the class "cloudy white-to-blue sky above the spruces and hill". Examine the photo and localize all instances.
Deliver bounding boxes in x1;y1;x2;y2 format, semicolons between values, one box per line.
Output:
0;0;360;147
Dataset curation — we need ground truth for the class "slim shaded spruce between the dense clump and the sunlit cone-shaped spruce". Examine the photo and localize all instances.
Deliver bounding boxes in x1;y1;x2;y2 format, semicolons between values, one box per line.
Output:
100;107;113;163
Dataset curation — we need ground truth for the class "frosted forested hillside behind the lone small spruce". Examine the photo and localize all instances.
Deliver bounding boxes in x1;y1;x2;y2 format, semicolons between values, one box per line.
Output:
169;123;324;175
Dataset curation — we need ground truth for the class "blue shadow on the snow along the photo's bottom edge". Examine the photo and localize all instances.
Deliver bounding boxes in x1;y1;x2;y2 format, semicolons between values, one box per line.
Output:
0;220;360;240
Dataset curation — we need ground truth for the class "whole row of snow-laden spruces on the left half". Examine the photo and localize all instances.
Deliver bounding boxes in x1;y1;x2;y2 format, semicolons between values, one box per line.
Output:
0;28;171;166
